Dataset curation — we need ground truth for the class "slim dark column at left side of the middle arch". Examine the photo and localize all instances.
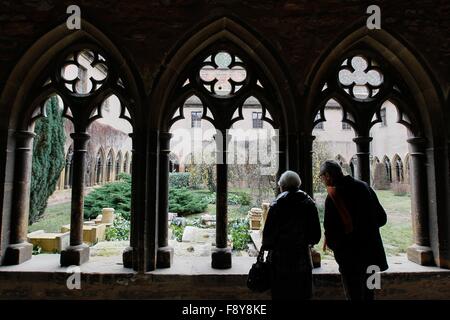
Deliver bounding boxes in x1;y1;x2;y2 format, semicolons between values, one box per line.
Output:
156;132;173;268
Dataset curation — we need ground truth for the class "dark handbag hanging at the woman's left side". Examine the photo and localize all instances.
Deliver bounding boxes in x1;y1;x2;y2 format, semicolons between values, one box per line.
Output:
247;250;272;292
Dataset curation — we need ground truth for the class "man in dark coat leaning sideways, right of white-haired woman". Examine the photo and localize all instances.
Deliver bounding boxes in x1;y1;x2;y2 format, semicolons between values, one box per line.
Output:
320;160;388;300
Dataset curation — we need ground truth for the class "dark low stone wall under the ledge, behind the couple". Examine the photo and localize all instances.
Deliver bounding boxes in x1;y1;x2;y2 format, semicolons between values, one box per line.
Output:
0;272;450;300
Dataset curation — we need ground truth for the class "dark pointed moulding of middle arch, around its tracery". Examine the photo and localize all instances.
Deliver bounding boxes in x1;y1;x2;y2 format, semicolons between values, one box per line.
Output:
149;17;297;136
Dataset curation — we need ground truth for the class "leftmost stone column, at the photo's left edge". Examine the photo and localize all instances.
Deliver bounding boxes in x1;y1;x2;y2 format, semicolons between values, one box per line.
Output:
4;131;35;265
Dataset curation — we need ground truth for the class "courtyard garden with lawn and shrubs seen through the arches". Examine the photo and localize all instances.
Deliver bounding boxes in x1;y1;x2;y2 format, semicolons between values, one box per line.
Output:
29;173;412;259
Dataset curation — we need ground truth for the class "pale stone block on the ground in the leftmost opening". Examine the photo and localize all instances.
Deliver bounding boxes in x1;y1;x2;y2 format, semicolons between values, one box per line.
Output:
27;230;70;253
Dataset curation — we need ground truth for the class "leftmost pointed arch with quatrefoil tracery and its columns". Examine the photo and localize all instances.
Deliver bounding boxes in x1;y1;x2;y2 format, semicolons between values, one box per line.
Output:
0;19;145;265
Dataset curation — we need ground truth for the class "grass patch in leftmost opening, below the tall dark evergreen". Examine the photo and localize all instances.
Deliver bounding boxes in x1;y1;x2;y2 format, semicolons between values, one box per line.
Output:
28;202;70;232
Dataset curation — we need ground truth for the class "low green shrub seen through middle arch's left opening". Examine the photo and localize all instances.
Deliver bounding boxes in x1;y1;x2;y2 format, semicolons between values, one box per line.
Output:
169;188;208;215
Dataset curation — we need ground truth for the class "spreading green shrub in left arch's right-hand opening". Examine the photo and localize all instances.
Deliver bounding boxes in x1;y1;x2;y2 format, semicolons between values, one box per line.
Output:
84;173;131;220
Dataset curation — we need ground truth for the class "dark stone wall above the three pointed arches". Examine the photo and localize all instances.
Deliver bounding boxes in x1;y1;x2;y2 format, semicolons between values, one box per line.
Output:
0;0;450;99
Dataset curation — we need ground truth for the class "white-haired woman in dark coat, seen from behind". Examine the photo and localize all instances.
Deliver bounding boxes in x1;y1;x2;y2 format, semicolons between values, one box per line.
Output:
262;171;321;300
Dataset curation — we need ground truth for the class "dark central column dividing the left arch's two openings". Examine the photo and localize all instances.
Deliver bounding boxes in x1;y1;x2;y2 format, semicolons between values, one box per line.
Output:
61;132;89;267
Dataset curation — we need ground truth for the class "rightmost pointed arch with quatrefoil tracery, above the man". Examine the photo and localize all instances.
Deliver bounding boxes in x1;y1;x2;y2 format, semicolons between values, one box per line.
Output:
303;24;450;267
